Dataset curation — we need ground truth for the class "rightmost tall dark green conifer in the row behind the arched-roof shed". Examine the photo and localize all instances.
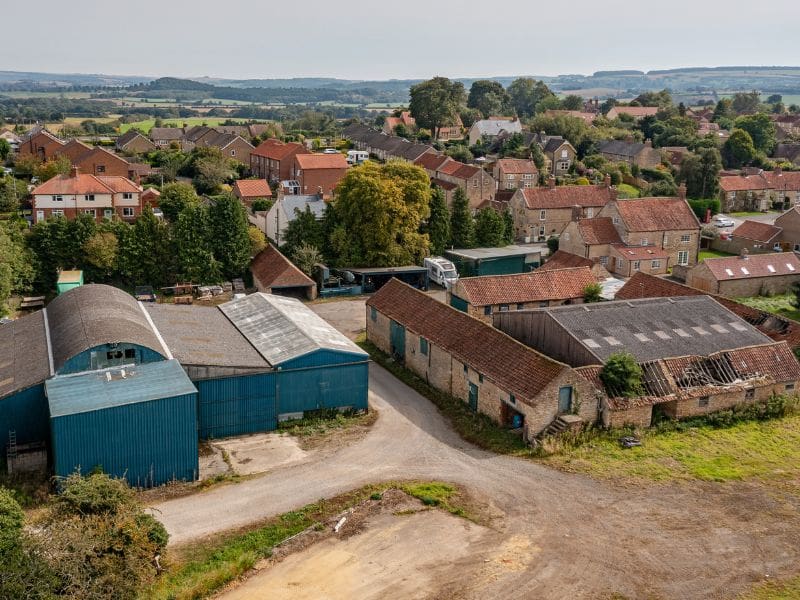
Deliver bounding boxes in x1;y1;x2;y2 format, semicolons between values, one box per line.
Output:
208;194;252;279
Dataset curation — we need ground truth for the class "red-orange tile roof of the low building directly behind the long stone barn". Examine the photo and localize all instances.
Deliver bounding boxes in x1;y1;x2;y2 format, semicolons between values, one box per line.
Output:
456;267;597;306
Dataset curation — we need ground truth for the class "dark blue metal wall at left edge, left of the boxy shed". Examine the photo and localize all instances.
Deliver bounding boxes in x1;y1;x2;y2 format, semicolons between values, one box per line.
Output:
0;384;50;450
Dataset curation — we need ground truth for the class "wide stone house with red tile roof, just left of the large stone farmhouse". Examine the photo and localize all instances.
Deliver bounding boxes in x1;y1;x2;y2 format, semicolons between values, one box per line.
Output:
509;176;617;242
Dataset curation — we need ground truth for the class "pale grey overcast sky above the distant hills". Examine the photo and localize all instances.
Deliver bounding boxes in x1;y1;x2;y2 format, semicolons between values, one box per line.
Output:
0;0;800;79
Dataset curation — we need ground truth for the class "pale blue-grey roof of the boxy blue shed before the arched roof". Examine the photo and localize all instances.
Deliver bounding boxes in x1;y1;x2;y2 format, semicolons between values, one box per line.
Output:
45;360;197;418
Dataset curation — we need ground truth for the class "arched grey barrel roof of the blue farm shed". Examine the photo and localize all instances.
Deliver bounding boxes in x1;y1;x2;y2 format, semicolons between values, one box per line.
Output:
47;284;165;372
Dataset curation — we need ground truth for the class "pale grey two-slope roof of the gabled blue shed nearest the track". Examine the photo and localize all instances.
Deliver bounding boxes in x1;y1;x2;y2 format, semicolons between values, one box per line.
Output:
219;293;366;366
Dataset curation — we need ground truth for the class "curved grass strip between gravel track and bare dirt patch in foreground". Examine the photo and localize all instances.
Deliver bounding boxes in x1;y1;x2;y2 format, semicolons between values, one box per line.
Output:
142;481;469;600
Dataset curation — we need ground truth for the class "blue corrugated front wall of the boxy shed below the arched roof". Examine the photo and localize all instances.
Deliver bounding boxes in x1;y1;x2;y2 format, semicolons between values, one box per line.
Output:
50;394;198;487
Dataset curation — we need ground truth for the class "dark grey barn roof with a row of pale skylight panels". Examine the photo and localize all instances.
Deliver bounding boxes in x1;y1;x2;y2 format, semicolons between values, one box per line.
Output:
541;296;770;361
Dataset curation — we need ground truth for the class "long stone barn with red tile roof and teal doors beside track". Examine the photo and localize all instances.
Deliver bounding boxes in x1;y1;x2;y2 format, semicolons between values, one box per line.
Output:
366;279;598;440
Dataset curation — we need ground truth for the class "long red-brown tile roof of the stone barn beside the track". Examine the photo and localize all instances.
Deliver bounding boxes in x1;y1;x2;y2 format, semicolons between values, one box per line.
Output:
367;279;569;403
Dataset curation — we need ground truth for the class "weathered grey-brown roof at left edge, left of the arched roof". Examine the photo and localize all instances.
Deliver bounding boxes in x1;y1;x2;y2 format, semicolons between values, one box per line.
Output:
0;310;50;398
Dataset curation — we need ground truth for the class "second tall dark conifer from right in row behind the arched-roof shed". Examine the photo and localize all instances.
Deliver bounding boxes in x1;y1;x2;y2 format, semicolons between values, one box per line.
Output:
172;204;222;283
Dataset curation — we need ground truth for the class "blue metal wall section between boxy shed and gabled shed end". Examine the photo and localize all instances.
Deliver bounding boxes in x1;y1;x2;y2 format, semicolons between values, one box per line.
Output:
194;373;278;439
